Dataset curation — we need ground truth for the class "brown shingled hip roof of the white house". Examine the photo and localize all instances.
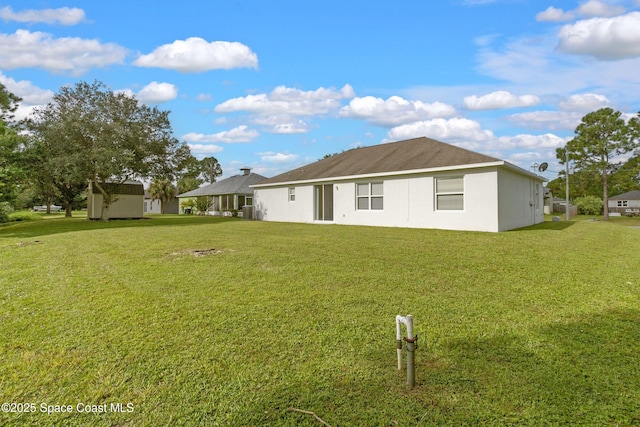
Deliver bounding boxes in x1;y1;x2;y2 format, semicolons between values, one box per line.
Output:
256;137;542;187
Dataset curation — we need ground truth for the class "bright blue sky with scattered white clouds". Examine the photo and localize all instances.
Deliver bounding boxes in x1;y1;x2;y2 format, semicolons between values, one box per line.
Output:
0;0;640;180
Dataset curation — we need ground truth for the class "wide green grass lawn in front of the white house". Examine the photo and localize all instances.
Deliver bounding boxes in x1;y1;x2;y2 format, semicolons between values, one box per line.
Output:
0;216;640;427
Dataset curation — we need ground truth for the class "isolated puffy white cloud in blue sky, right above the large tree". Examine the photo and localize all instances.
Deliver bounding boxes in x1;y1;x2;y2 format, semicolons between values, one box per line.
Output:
133;37;258;73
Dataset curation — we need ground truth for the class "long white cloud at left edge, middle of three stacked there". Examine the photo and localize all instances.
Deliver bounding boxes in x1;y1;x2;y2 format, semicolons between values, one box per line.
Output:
0;30;127;76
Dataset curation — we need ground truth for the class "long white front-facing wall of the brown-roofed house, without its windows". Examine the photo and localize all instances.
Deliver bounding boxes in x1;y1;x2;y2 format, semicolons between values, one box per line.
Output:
254;168;528;232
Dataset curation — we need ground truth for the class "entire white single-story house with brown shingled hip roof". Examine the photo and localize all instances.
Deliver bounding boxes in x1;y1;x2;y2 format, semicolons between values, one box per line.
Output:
253;137;545;232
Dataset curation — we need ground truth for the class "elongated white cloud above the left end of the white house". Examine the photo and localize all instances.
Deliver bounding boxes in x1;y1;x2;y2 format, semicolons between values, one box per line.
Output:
215;85;354;116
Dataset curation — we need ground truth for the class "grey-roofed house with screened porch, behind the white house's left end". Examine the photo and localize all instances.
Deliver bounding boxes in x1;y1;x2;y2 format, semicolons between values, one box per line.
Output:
177;167;267;215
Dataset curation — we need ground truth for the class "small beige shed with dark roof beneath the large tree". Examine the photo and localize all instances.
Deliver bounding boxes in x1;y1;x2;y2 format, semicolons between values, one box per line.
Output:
87;181;144;219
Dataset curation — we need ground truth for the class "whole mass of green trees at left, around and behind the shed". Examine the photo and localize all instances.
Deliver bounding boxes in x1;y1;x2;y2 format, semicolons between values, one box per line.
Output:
0;81;222;219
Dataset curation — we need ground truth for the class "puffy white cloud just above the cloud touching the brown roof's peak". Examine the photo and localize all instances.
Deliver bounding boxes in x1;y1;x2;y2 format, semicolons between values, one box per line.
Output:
340;96;456;126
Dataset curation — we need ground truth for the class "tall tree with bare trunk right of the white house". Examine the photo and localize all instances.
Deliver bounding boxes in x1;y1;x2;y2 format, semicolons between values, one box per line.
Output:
556;108;636;220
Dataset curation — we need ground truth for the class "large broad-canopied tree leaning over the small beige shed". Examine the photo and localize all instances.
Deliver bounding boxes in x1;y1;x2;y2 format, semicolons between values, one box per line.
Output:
28;81;188;220
